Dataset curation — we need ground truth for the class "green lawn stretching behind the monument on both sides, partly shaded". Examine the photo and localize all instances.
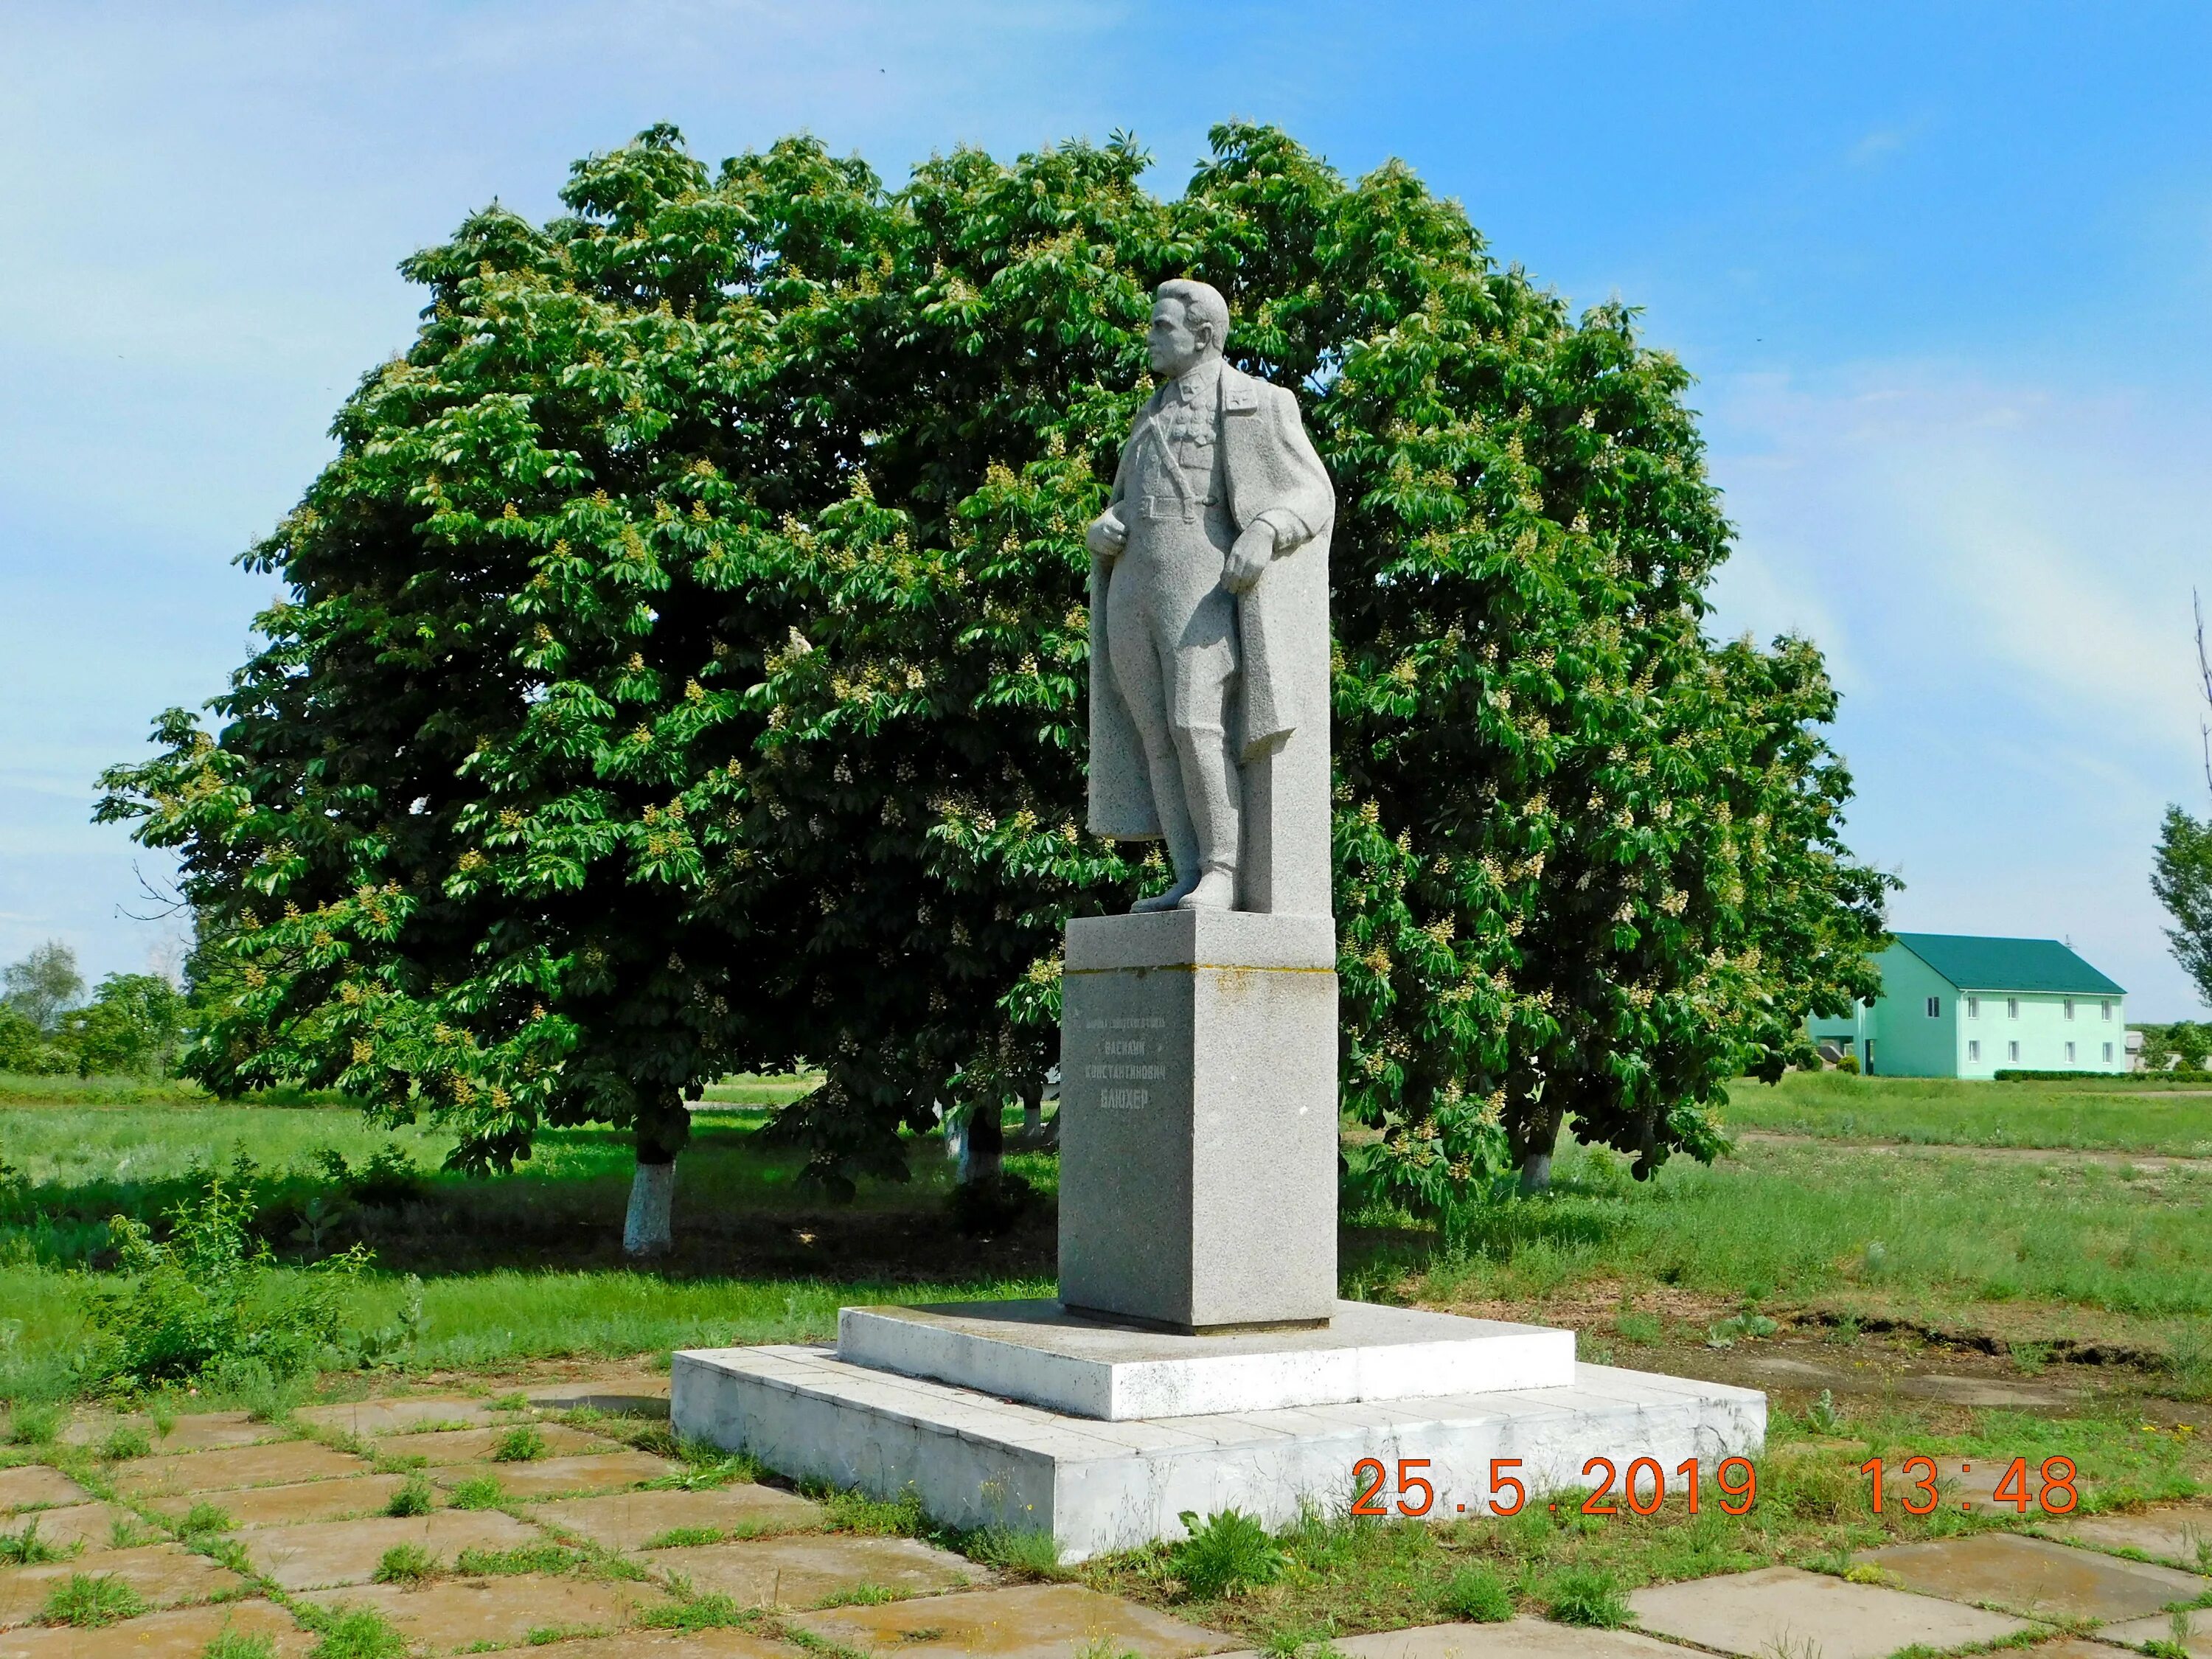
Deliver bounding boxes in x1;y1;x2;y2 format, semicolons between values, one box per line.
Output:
0;1077;2212;1394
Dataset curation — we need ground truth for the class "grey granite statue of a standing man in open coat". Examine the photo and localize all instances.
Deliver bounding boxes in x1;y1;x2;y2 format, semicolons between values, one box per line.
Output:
1088;281;1336;914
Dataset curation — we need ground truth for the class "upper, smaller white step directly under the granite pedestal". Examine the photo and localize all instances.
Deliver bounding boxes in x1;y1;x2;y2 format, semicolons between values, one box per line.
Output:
836;1298;1575;1422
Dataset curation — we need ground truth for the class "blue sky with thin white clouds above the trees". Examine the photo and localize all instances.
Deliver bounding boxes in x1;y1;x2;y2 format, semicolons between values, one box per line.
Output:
0;0;2212;1018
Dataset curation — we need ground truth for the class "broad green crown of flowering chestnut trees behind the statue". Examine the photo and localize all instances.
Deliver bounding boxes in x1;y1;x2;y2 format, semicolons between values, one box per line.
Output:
100;126;1885;1210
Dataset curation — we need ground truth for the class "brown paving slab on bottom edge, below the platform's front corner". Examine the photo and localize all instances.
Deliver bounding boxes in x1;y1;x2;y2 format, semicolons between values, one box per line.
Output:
792;1584;1230;1659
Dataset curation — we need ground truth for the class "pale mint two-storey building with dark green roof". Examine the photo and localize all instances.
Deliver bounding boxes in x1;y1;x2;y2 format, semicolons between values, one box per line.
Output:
1809;933;2128;1077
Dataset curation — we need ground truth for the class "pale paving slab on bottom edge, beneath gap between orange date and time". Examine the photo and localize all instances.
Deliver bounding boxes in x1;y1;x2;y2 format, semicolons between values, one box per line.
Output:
1628;1566;2031;1659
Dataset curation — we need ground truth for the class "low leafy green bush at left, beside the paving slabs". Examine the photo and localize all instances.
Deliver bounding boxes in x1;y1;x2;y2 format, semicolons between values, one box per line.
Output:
88;1177;367;1385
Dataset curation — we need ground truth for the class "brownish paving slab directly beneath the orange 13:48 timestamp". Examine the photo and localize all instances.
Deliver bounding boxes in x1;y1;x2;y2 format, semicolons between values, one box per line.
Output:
1858;1533;2212;1621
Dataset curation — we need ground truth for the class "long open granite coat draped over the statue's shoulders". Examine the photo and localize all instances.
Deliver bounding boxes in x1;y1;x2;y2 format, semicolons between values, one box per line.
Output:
1091;363;1336;841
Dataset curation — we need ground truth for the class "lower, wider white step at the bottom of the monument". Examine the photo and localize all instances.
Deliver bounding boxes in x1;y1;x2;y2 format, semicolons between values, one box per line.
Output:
670;1338;1767;1559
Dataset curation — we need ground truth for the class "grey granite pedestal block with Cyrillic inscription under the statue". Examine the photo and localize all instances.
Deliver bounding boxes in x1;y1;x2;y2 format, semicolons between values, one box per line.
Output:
1060;911;1336;1329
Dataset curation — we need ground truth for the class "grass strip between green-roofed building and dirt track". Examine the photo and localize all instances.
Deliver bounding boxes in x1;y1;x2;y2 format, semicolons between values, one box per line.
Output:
1725;1071;2212;1157
